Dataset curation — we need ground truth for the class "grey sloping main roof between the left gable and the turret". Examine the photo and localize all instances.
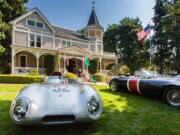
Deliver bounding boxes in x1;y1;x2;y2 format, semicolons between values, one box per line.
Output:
53;26;88;42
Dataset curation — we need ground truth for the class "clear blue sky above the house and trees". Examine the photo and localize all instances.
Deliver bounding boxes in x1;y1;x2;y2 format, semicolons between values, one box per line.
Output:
25;0;155;30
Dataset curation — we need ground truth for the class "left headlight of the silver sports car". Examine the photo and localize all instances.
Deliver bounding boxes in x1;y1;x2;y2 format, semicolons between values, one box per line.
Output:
13;98;30;121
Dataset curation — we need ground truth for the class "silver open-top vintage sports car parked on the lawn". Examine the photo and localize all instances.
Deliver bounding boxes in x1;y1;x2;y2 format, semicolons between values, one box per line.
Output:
10;76;102;125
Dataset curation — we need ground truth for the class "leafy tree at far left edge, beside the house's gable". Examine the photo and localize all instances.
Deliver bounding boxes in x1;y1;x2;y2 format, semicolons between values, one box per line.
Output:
0;0;28;73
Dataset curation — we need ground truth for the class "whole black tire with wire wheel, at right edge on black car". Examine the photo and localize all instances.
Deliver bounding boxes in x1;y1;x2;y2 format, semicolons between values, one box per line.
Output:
163;87;180;107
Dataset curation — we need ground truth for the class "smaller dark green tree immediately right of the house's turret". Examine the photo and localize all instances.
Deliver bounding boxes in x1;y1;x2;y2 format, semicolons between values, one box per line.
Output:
104;24;119;53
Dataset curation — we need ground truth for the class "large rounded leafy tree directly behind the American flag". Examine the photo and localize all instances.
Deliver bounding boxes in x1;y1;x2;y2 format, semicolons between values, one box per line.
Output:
117;17;149;74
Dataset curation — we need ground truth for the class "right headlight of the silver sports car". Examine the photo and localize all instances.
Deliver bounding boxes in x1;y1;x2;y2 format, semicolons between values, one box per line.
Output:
87;97;102;119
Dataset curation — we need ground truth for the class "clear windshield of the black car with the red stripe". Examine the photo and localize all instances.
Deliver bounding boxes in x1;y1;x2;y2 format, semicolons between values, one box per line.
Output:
135;70;161;79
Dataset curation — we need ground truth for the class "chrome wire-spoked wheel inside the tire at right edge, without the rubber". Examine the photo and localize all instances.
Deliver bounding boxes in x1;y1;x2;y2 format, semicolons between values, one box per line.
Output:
166;89;180;107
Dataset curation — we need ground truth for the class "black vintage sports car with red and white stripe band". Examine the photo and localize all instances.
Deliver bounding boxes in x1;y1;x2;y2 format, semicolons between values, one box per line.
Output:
109;70;180;107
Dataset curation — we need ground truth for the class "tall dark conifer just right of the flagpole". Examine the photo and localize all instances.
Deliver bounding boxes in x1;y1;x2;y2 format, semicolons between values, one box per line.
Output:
152;0;171;73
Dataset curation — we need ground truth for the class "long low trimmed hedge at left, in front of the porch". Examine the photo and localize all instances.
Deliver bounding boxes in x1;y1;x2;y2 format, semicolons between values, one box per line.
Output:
0;75;44;84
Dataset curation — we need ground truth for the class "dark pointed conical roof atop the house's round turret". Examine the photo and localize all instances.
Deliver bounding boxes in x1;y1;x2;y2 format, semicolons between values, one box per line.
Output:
87;8;101;26
